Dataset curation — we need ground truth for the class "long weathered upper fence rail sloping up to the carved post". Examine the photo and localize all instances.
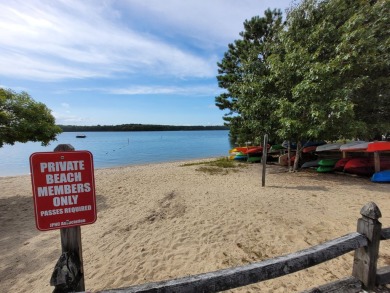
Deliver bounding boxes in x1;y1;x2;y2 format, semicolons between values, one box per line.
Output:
100;232;367;293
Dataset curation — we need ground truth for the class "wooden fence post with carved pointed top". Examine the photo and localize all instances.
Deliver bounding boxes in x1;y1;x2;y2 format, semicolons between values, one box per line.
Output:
352;202;382;290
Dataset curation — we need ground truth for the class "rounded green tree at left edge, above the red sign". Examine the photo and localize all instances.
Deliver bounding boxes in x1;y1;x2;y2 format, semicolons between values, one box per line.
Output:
0;88;61;147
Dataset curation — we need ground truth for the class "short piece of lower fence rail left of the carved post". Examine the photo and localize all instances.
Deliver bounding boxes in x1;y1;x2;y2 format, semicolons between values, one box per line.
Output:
301;277;362;293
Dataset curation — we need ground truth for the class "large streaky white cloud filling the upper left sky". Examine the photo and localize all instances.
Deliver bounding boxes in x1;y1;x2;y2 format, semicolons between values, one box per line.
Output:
0;0;221;80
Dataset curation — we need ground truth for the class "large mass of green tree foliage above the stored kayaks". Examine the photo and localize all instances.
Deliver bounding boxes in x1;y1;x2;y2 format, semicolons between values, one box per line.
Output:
216;0;390;151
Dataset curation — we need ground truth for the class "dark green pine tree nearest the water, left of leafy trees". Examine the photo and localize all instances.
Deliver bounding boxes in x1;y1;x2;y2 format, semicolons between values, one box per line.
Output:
215;9;282;143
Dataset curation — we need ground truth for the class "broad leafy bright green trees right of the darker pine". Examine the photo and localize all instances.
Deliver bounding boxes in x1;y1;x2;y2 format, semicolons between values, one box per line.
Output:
269;0;389;168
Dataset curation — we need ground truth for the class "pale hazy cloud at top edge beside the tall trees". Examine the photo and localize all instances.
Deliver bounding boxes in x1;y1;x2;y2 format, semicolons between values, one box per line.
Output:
120;0;292;46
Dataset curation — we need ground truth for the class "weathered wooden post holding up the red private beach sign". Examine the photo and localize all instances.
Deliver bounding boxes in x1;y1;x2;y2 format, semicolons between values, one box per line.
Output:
54;144;85;292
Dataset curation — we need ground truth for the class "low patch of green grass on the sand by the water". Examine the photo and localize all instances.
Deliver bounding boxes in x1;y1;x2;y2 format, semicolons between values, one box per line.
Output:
181;157;246;175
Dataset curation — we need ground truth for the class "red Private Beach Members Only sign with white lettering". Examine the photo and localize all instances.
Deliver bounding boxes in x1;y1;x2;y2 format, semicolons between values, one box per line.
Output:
30;151;96;231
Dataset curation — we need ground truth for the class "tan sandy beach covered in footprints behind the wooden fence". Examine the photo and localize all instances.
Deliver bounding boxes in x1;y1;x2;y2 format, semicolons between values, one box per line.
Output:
0;162;390;293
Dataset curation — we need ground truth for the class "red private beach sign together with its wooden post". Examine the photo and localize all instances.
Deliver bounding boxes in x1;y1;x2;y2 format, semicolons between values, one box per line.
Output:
30;144;96;292
